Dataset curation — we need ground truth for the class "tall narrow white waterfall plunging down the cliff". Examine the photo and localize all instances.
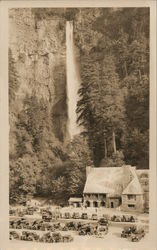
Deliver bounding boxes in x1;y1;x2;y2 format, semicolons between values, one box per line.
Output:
66;21;80;139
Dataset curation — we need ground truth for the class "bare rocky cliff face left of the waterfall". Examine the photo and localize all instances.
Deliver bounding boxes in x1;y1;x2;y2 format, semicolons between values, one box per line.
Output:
9;8;67;141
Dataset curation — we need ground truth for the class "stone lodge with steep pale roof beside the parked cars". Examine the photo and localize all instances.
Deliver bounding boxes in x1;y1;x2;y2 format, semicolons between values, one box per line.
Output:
83;165;149;212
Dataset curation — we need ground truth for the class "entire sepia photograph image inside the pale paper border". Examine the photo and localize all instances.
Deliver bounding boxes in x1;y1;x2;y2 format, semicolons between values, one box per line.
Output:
0;0;155;250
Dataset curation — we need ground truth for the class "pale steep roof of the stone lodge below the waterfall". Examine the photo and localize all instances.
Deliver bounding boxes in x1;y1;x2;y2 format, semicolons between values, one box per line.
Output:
84;166;142;196
